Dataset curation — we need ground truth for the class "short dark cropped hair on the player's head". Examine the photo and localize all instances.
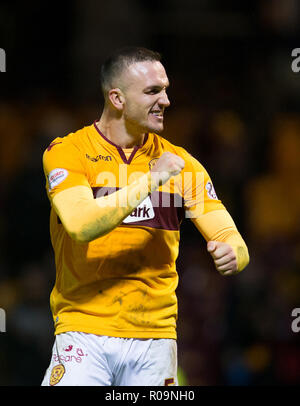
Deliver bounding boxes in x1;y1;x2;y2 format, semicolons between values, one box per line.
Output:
100;46;161;96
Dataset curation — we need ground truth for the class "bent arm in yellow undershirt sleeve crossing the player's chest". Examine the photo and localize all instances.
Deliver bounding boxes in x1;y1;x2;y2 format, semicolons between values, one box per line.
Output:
53;172;157;242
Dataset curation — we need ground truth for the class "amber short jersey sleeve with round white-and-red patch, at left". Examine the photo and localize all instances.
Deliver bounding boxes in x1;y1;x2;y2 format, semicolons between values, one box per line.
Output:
43;136;90;201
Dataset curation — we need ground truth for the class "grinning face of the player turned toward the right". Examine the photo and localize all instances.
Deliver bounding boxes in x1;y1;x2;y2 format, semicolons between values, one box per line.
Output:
123;61;170;133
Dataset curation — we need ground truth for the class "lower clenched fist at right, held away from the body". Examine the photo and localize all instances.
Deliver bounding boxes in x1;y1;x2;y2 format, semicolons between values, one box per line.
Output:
207;241;239;276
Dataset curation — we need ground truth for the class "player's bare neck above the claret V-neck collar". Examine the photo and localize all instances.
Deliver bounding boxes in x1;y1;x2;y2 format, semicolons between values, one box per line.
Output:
96;109;146;148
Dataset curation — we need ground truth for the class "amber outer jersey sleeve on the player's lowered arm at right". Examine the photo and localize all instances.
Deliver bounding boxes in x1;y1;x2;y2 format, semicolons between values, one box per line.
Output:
176;149;225;218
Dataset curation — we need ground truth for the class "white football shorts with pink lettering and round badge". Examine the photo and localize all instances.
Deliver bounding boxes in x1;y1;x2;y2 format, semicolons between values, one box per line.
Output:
42;331;178;386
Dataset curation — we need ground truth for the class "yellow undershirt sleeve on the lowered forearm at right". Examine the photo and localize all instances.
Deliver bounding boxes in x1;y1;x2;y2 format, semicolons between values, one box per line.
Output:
192;210;249;271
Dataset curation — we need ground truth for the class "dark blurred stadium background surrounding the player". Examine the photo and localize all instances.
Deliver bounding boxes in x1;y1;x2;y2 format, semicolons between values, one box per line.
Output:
0;0;300;385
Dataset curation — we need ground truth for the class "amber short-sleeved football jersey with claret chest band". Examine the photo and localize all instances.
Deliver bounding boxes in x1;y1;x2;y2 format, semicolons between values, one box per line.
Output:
43;123;225;339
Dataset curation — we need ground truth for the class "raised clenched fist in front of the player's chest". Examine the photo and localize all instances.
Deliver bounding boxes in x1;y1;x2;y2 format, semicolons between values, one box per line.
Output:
151;152;185;185
